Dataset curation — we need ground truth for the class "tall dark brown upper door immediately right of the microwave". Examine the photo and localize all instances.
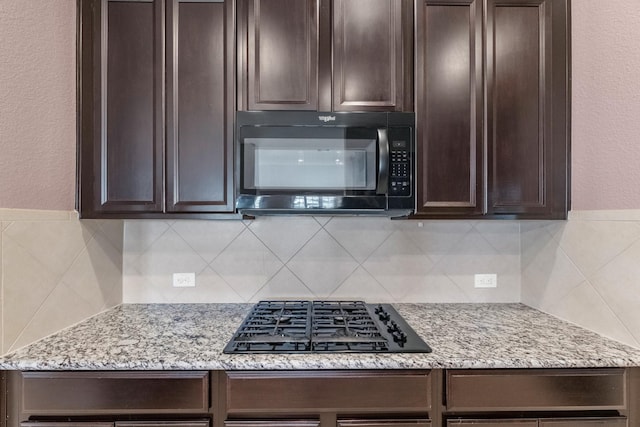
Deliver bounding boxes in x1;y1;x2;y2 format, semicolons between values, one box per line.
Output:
416;0;483;215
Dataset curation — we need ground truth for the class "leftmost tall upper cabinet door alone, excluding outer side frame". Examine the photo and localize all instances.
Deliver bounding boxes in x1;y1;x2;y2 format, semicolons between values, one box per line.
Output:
94;0;164;212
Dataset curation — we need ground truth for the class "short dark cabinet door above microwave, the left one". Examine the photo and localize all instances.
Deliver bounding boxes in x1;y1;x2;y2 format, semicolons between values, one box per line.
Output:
238;0;319;110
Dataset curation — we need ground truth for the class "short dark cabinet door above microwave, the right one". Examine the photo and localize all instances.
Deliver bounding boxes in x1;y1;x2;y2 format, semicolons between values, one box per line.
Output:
333;0;413;111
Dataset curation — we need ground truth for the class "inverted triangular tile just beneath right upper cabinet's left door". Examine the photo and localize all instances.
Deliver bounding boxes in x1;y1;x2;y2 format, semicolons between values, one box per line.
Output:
398;221;473;262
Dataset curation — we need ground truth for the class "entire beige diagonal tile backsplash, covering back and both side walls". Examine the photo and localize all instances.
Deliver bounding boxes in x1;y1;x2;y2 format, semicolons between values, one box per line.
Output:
5;209;640;354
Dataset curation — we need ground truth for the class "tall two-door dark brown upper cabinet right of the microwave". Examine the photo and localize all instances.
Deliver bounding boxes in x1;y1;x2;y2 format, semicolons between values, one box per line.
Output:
416;0;570;219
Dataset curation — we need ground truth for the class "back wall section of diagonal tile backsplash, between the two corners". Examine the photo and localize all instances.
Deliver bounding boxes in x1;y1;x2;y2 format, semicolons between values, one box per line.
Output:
123;221;520;303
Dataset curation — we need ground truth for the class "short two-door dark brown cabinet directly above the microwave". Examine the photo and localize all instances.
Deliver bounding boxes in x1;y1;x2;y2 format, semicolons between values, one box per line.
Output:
238;0;413;111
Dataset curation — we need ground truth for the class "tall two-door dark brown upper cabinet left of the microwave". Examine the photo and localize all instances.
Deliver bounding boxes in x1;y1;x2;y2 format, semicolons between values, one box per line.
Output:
78;0;235;218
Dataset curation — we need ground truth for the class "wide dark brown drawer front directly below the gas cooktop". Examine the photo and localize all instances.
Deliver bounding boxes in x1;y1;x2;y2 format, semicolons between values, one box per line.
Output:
226;371;431;414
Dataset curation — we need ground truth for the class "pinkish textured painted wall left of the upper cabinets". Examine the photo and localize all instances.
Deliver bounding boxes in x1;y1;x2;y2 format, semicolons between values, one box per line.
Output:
0;0;76;210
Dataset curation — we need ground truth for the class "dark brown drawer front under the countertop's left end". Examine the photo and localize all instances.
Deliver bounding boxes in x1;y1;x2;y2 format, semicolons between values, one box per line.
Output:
22;371;209;415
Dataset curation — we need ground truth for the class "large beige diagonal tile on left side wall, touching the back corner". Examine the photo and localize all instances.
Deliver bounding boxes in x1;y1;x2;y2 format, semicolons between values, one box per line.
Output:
62;233;122;314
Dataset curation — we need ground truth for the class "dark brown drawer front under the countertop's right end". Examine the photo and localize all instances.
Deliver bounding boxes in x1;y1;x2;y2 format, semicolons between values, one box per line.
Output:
446;369;627;411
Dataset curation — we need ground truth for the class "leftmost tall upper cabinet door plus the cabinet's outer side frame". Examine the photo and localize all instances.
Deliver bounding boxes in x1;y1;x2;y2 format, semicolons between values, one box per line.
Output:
80;0;164;216
